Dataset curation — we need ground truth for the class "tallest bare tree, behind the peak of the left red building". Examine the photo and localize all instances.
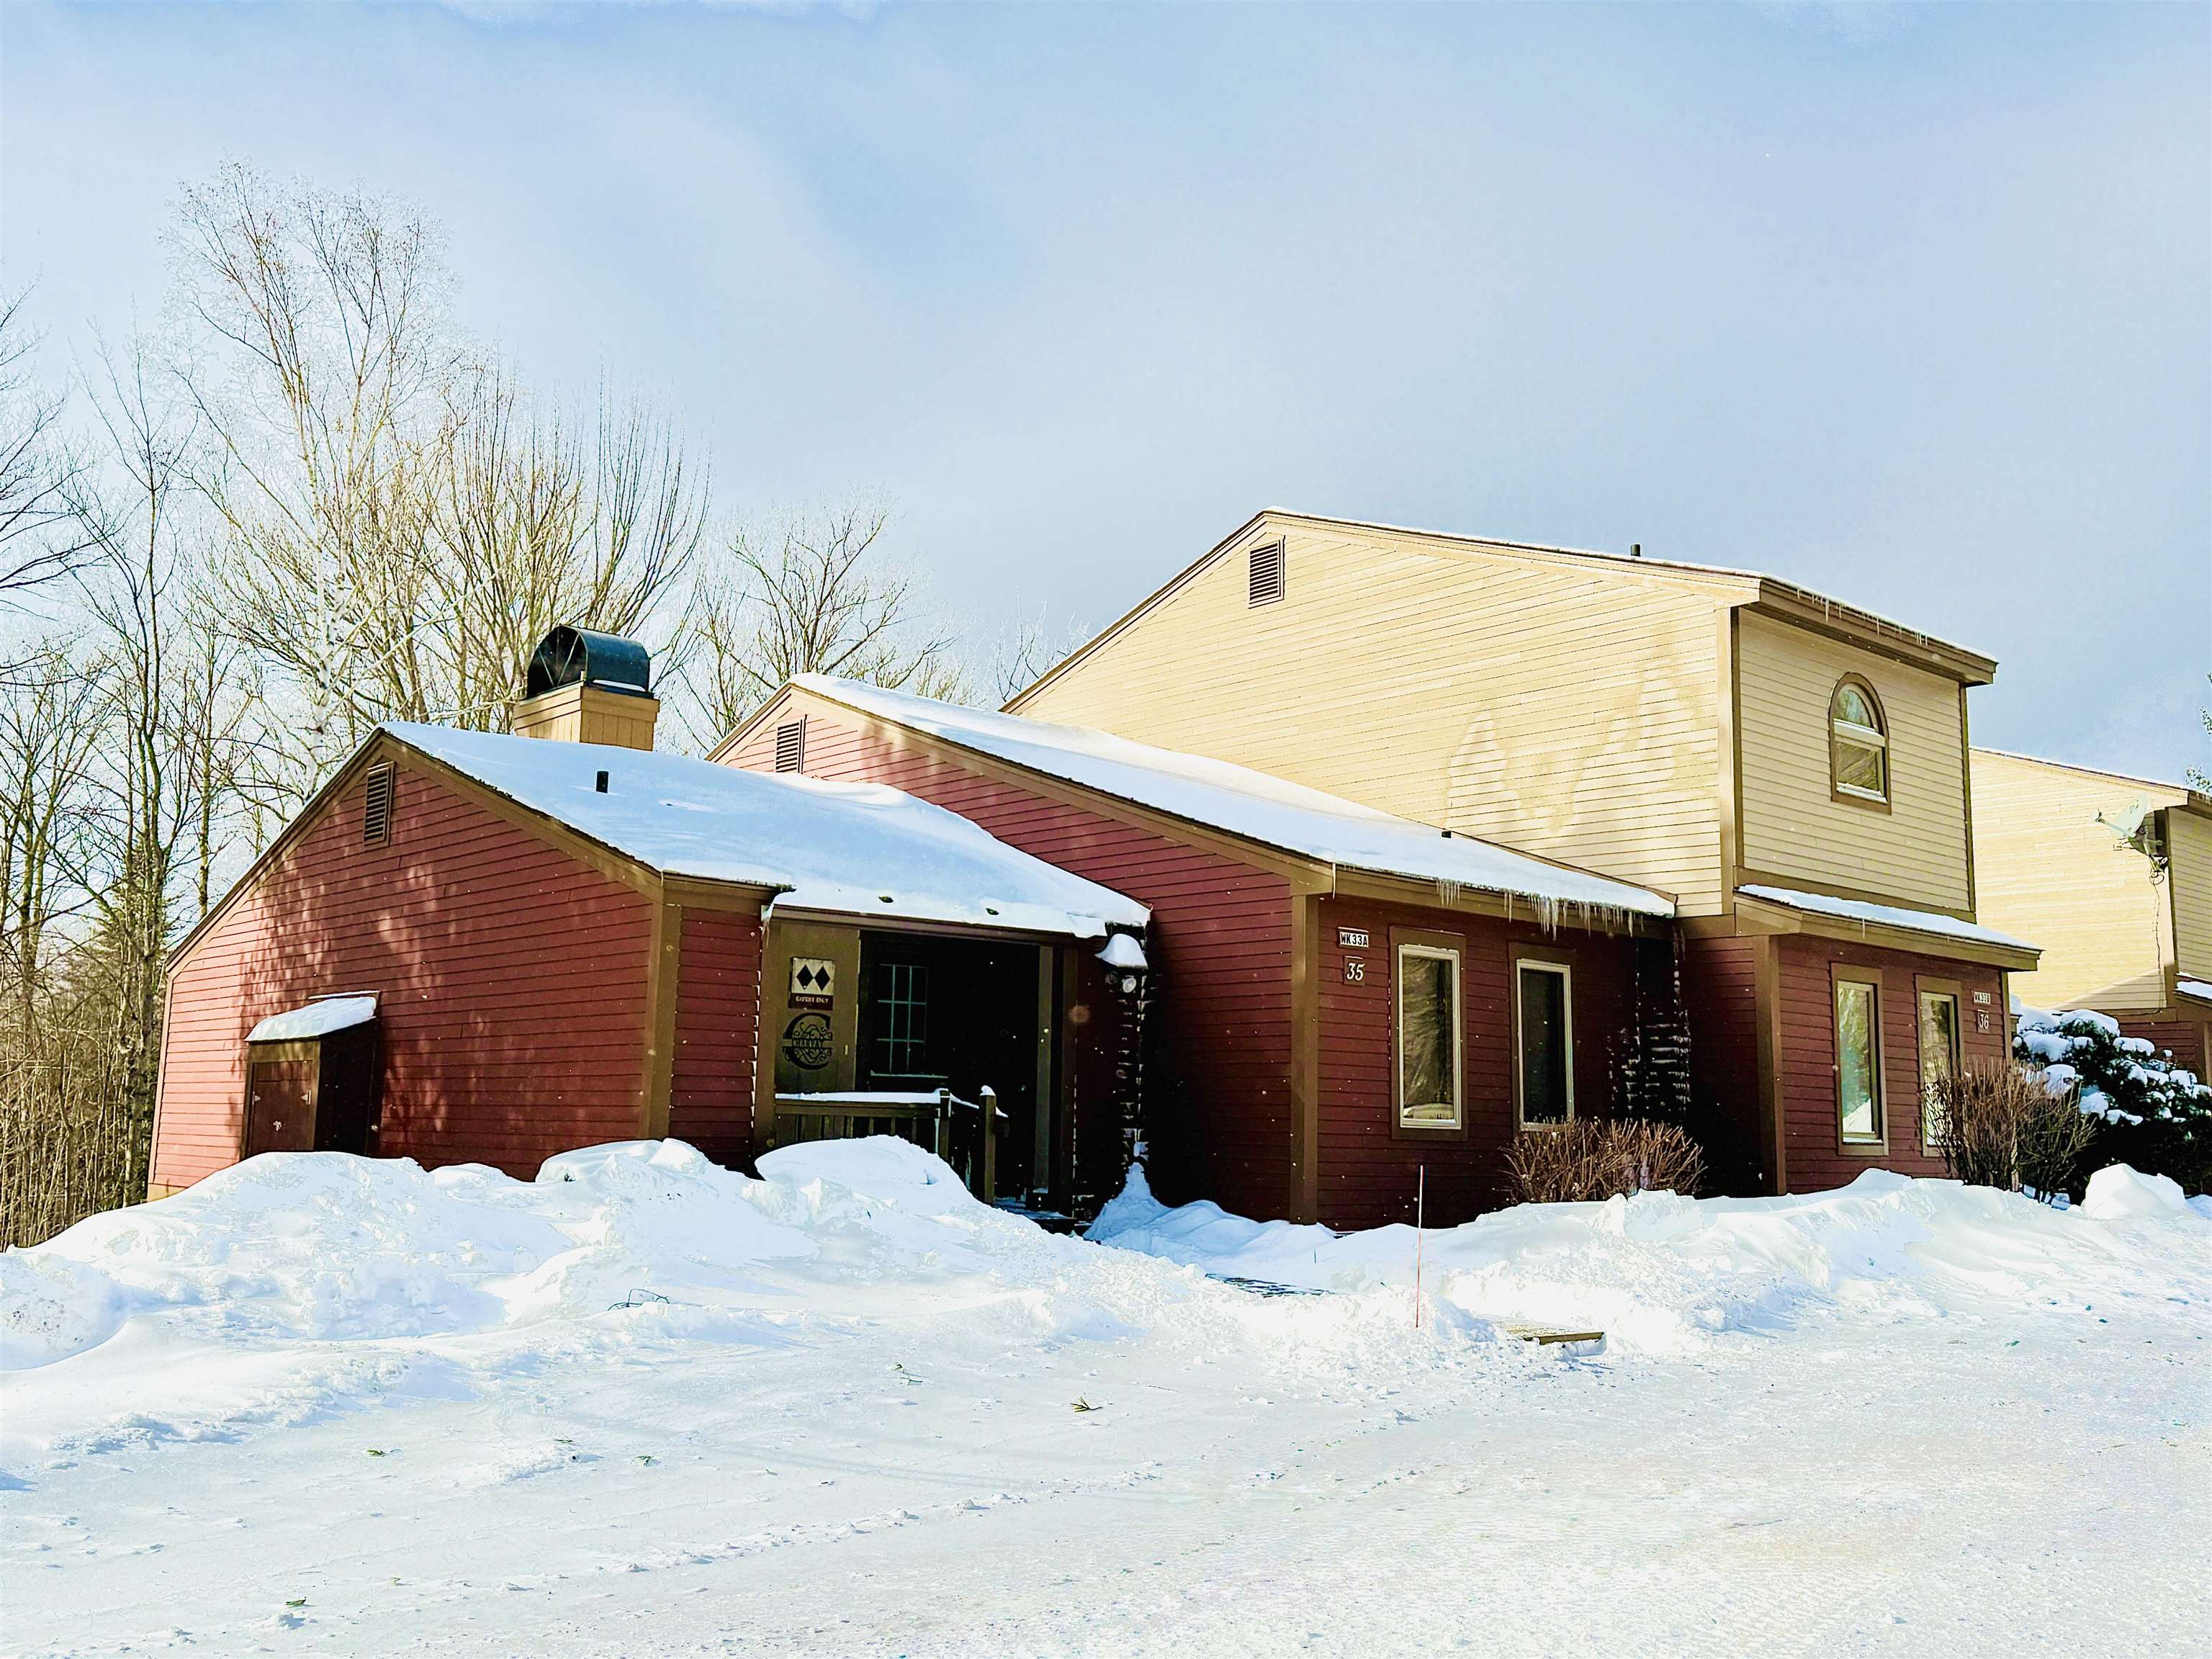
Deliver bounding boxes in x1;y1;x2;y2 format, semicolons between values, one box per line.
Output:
171;163;462;792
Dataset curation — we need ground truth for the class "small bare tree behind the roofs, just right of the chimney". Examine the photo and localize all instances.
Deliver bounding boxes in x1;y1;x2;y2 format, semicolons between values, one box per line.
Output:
688;504;964;734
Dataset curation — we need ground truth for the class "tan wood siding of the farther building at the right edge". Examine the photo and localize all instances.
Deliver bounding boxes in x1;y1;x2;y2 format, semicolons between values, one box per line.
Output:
1973;750;2176;1013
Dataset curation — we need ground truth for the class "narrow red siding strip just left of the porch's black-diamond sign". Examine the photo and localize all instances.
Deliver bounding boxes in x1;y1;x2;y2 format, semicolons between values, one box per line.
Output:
668;909;761;1168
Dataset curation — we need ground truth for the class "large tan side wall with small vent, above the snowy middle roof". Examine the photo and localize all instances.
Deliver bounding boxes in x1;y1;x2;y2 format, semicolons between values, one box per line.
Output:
1020;526;1723;914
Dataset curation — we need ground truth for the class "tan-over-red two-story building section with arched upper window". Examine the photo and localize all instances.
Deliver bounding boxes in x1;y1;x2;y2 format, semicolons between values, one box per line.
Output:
1009;511;2035;1192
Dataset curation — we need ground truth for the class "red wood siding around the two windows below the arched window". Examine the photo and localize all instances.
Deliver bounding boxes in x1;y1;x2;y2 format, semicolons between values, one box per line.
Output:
1776;935;2008;1192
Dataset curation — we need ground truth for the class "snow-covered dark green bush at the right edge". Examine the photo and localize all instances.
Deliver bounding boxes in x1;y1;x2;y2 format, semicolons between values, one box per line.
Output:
2013;1009;2212;1192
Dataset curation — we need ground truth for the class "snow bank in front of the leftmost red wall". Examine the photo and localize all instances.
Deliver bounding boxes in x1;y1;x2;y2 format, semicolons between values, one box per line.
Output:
0;1141;832;1370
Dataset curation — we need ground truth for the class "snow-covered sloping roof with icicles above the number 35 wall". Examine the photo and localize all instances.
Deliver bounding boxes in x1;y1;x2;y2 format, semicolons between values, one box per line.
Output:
792;675;1675;916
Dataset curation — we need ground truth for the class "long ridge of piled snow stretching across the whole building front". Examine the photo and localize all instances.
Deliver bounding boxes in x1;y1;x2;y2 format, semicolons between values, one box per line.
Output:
0;1139;2212;1370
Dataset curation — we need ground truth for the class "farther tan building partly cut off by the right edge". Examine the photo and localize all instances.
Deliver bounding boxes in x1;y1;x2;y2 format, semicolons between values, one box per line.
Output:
1973;750;2212;1077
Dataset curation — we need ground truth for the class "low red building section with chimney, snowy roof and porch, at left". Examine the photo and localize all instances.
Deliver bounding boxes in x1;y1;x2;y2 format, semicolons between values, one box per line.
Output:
150;642;1146;1201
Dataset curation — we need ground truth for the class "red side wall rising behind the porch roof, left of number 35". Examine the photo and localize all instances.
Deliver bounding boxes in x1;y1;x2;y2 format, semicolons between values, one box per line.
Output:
724;710;1294;1217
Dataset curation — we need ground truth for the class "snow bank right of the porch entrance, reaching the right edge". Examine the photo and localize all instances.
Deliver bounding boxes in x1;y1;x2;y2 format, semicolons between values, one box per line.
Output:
1088;1166;2212;1354
